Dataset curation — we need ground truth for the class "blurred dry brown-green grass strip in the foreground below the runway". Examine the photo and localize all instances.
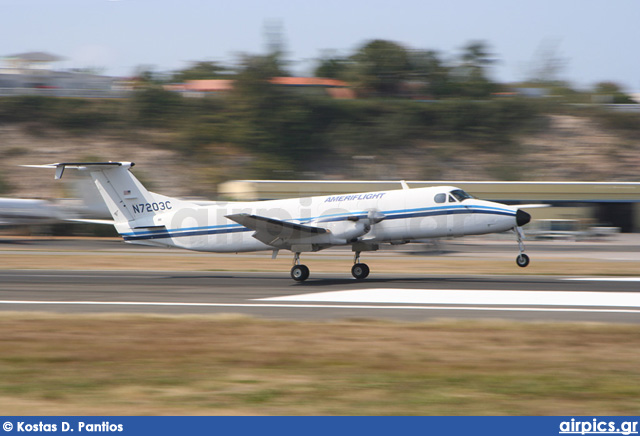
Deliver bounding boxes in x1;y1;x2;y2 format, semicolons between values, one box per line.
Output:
0;313;640;415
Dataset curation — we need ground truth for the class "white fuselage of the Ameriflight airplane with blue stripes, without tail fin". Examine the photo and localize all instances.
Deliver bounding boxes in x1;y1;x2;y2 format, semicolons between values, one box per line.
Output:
116;186;521;252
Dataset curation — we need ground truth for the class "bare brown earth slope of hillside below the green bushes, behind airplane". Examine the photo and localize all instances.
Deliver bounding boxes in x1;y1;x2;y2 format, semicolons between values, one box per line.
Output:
0;115;640;198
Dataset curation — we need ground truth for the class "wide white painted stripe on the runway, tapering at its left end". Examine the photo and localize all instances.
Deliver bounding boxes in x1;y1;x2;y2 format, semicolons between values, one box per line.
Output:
259;288;640;308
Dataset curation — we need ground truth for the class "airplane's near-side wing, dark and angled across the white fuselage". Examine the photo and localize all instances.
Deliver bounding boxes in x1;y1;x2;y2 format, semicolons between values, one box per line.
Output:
226;213;329;246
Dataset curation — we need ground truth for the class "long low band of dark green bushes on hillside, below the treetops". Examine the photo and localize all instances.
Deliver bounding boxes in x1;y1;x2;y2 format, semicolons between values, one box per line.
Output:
0;92;539;175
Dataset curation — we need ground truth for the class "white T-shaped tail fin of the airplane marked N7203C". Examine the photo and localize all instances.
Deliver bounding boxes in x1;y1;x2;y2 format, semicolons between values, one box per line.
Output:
33;162;190;233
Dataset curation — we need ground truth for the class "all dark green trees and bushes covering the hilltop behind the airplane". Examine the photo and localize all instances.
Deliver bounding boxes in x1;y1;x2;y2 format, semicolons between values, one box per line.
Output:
0;40;640;178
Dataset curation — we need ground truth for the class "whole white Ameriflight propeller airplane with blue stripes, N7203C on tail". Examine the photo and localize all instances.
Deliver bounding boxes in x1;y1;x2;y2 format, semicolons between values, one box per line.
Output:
29;162;531;282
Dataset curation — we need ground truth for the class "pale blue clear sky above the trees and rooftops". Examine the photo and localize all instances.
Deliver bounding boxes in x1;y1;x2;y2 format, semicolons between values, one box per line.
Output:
5;0;640;92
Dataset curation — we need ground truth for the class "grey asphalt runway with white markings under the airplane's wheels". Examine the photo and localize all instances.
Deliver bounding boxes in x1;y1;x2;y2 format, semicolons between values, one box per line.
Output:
0;270;640;323
